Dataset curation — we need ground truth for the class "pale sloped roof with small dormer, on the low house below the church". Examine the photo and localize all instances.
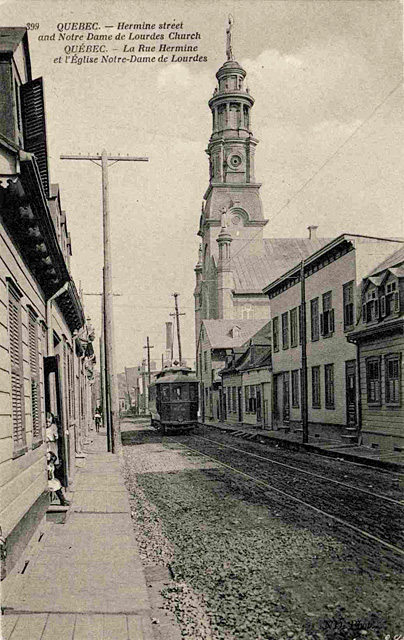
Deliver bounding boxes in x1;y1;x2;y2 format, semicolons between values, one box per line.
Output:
203;318;268;349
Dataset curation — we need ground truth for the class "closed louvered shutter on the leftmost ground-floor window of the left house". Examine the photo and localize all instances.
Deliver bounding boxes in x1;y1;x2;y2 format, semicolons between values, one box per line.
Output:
8;285;26;453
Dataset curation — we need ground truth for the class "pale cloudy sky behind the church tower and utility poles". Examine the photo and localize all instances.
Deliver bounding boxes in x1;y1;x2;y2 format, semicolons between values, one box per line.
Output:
0;0;404;371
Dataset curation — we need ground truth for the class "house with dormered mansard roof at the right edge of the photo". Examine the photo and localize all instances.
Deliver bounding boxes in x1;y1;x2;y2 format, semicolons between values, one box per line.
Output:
347;248;404;451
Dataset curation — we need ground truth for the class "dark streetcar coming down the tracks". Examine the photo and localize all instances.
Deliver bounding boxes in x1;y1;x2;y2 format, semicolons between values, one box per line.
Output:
149;366;199;434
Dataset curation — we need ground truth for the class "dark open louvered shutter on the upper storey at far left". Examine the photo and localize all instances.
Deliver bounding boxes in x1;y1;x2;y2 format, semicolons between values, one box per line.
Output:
20;78;49;198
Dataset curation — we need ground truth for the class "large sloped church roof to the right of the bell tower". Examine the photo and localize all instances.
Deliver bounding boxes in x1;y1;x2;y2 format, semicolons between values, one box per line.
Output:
232;238;331;291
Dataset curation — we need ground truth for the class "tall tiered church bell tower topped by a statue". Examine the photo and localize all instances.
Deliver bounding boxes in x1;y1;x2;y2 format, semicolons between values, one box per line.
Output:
195;17;267;328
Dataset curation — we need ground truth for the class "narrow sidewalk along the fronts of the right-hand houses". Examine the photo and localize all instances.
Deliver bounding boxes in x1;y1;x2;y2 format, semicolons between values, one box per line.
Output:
199;422;404;473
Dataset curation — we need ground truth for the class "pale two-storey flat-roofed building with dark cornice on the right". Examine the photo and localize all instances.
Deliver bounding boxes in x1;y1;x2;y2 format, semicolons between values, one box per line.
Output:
264;234;404;442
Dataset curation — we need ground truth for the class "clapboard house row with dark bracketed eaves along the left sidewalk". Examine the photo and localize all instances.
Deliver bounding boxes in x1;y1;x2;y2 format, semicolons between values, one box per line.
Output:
0;28;94;577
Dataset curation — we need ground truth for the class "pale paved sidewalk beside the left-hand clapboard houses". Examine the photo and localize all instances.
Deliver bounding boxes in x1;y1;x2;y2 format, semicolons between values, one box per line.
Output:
0;432;160;640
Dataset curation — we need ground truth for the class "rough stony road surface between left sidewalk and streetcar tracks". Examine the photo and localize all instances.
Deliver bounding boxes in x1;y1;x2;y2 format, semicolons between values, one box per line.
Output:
123;424;403;640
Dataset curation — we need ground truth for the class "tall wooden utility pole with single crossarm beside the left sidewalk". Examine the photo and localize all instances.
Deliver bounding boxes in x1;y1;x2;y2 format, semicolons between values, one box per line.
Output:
60;149;148;453
